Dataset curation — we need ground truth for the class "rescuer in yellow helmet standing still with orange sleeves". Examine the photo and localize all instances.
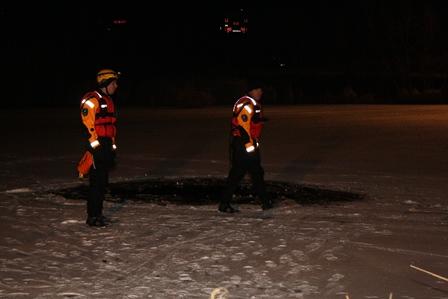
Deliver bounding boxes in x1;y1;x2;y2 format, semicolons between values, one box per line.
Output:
80;69;119;226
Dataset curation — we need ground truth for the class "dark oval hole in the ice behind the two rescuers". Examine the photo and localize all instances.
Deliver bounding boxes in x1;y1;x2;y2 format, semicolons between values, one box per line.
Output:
52;178;364;205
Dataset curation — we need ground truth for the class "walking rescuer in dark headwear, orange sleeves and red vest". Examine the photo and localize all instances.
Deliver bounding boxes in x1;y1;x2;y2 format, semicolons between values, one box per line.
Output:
218;81;273;213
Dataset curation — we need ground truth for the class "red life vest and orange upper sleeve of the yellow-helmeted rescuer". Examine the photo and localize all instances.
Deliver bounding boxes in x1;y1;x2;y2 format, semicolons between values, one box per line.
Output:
81;91;116;139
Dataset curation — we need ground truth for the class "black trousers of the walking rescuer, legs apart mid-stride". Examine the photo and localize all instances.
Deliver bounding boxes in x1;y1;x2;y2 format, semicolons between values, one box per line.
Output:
221;152;269;205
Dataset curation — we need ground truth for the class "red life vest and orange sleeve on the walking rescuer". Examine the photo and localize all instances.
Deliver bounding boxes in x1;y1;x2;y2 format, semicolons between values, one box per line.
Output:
231;96;263;153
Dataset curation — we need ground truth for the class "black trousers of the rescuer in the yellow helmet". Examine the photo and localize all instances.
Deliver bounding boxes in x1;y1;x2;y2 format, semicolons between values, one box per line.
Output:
87;138;115;217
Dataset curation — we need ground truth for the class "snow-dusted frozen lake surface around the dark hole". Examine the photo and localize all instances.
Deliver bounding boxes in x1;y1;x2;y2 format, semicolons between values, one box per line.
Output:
0;105;448;299
